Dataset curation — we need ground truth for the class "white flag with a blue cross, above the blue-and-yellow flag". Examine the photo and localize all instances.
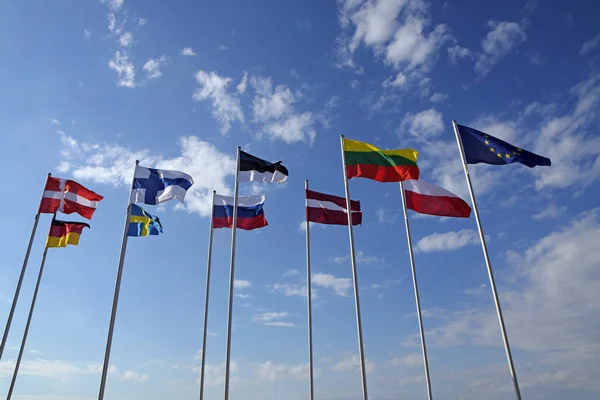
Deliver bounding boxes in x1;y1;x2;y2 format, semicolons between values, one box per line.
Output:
131;166;194;205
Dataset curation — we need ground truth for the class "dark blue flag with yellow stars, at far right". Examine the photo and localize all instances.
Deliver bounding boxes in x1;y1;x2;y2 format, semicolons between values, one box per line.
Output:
456;124;551;168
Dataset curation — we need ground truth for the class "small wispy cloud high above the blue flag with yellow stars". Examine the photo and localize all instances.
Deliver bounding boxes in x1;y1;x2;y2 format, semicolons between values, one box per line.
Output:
475;21;527;76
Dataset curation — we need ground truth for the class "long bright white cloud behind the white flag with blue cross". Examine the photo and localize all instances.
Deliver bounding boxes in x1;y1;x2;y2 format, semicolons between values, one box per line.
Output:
59;132;235;217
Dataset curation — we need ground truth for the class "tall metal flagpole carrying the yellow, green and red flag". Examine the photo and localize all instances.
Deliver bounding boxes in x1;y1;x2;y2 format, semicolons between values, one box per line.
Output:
340;135;369;400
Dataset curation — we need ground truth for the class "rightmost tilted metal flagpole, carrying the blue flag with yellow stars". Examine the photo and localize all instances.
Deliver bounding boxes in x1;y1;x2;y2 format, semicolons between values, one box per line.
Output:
452;121;521;400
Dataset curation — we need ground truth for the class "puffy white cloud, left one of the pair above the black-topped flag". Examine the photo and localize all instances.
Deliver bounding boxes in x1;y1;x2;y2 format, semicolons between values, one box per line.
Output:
194;71;244;134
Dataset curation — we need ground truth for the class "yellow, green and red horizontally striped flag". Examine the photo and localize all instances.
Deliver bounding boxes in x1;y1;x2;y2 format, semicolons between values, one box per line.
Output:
344;139;419;182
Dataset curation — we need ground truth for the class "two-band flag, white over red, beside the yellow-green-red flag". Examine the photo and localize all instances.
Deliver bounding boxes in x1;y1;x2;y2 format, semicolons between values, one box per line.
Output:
402;180;471;218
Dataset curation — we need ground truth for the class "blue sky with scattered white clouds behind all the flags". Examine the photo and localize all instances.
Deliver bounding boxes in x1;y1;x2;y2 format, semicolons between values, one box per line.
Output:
0;0;600;400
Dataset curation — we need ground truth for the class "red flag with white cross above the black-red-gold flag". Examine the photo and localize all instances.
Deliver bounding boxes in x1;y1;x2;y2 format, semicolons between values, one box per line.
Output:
39;176;104;219
